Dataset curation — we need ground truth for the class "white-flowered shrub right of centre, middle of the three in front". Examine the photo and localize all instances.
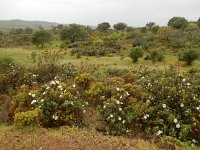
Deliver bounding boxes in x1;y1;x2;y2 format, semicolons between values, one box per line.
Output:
97;84;147;135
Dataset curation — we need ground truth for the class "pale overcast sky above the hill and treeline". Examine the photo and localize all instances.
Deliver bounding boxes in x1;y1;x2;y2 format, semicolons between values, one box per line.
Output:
0;0;200;26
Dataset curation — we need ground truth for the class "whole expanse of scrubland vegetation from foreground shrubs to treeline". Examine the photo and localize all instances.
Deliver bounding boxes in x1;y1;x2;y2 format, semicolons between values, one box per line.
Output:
0;17;200;149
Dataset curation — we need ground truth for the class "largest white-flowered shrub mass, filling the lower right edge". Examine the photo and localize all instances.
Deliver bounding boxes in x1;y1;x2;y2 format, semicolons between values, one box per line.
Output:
138;68;200;143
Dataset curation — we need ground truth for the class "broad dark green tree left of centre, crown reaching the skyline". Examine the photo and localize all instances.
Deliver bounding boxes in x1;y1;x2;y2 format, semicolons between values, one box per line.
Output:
61;24;87;43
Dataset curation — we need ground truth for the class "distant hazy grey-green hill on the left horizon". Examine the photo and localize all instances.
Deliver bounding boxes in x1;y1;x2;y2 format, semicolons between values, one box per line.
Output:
0;19;58;29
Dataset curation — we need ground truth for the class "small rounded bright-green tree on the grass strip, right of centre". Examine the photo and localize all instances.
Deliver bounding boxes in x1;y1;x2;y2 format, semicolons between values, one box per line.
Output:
129;46;144;63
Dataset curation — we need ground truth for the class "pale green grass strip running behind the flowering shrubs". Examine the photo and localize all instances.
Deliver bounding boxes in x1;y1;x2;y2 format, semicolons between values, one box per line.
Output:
0;46;200;71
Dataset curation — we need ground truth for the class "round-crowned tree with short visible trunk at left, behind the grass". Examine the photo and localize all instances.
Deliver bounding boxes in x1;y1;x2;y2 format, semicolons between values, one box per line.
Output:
32;30;52;48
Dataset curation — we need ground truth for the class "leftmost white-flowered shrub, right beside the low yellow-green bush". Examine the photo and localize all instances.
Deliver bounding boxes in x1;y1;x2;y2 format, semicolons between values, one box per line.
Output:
32;80;88;127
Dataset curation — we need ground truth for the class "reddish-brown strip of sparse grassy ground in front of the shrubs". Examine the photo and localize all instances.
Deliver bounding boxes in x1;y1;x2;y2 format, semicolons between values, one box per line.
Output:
0;126;198;150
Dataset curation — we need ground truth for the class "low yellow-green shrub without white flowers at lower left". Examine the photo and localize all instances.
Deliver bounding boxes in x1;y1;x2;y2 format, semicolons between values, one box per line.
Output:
14;108;41;128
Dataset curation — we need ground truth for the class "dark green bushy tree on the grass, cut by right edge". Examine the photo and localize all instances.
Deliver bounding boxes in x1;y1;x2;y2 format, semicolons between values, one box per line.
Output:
179;49;199;65
